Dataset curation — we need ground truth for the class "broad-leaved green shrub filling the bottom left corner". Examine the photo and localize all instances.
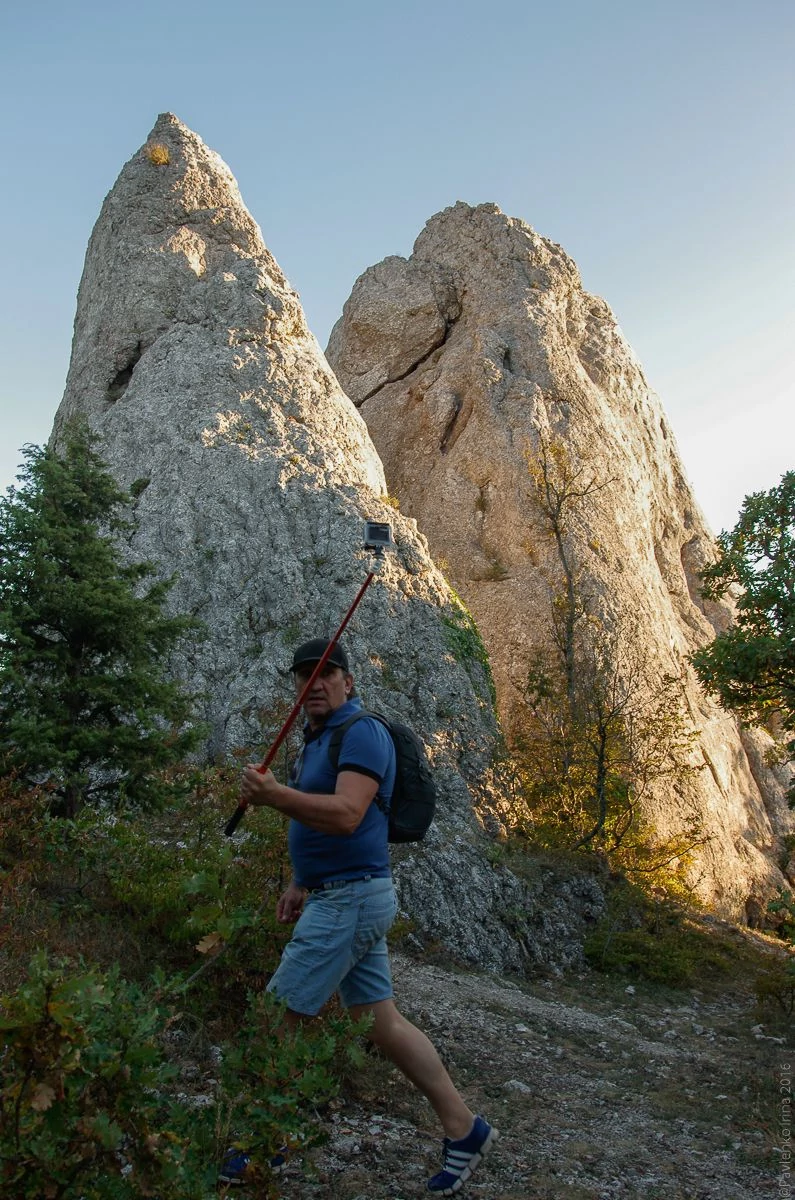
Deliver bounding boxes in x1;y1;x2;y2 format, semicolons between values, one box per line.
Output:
0;952;201;1200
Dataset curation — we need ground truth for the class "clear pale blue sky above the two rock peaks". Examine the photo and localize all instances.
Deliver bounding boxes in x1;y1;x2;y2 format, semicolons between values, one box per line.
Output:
0;0;795;530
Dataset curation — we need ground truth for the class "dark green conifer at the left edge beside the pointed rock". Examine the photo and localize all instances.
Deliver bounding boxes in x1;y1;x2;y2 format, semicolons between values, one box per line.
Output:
0;425;202;816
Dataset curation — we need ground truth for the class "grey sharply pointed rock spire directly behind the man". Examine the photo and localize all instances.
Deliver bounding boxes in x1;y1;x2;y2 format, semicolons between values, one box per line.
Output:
53;114;602;970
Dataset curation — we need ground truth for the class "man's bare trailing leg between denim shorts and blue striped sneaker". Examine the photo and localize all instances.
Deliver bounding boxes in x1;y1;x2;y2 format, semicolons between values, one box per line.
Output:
348;1000;474;1140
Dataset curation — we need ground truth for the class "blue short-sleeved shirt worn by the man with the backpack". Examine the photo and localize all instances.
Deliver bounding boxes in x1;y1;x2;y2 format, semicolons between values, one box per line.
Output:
288;700;395;888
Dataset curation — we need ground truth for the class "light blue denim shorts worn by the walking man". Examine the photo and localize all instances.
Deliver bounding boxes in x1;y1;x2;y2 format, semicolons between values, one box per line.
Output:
268;878;398;1016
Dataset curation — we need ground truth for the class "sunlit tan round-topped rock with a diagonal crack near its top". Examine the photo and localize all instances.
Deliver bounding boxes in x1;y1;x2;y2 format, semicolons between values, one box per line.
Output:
327;203;791;918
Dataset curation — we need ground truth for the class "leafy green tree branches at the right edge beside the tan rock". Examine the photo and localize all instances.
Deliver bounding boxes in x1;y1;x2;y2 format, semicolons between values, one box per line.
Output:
693;470;795;799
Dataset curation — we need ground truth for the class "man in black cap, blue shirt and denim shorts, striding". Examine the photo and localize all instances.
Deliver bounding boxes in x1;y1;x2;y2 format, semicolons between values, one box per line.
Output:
230;638;497;1195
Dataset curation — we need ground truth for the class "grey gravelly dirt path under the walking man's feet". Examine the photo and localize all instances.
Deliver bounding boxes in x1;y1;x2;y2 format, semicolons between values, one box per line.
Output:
281;955;791;1200
